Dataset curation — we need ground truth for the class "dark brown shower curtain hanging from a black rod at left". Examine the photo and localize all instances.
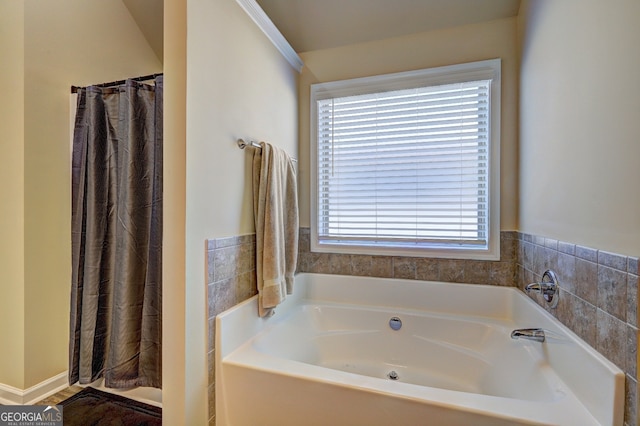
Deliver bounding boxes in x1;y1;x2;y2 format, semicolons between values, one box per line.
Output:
69;77;163;388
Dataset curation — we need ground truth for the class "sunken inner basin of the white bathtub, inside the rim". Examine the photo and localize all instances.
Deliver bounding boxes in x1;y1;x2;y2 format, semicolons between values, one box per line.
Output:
251;304;567;401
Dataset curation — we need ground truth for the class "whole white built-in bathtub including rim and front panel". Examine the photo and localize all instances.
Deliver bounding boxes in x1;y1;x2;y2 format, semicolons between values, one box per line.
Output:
216;274;624;426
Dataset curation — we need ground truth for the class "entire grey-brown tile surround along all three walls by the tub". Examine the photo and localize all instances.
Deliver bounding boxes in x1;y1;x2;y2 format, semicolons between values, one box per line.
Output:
207;228;639;426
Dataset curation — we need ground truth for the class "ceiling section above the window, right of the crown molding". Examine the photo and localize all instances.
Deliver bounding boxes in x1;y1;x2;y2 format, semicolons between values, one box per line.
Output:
256;0;520;53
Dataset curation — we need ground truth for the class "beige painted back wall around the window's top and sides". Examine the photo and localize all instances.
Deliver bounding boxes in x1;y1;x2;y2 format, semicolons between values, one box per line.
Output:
299;18;518;230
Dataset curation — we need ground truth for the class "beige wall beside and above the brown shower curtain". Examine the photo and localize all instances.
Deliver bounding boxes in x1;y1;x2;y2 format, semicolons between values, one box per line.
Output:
0;0;162;389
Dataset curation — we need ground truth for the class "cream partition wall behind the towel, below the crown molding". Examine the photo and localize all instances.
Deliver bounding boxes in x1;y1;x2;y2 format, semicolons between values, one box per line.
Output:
170;0;297;425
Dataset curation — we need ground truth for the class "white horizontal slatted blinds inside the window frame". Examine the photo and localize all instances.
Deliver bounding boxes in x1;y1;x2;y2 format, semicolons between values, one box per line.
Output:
317;80;491;251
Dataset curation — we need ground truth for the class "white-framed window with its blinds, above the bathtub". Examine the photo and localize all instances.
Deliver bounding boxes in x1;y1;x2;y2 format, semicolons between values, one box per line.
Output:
311;59;500;259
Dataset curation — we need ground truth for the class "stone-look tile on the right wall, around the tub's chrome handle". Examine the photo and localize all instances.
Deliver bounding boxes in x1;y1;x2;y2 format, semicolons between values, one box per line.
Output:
515;233;638;425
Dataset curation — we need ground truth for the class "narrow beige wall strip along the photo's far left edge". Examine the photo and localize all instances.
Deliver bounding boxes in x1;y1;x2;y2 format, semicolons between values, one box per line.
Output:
0;0;25;388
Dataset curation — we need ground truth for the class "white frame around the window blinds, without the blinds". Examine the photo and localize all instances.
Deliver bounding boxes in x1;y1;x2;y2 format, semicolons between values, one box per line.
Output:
310;58;501;260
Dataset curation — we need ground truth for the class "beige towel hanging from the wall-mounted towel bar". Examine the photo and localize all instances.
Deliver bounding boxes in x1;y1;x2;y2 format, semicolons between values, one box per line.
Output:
253;142;298;317
